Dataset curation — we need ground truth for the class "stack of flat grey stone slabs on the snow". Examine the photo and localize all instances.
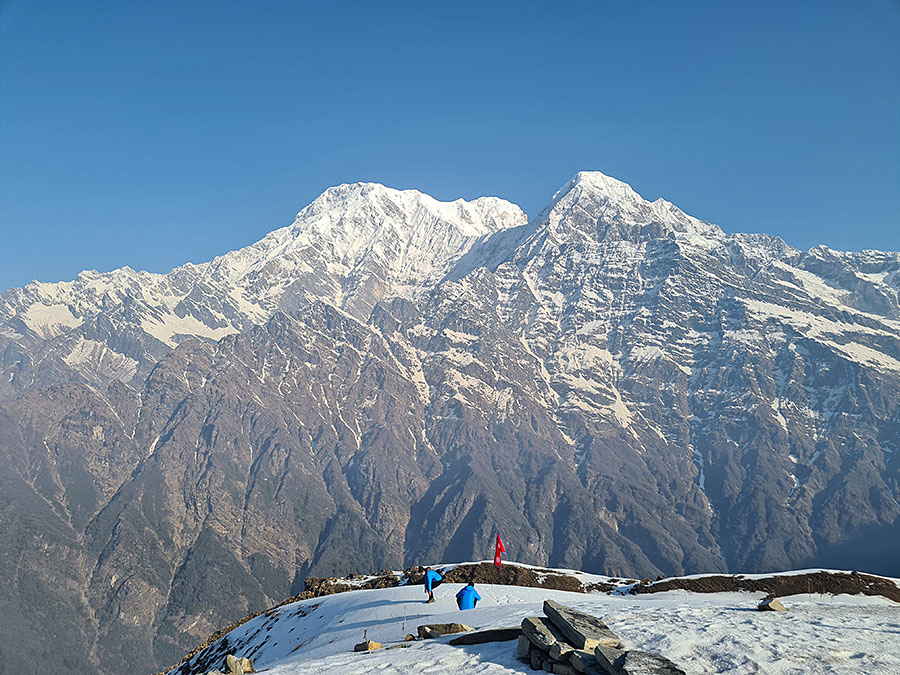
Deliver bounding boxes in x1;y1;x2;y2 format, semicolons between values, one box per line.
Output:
518;600;684;675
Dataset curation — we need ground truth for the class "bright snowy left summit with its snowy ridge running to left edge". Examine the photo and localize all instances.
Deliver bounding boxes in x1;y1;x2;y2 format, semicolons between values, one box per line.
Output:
0;183;527;380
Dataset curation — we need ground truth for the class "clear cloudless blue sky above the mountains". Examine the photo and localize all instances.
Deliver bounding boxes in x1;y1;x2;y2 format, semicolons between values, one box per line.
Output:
0;0;900;290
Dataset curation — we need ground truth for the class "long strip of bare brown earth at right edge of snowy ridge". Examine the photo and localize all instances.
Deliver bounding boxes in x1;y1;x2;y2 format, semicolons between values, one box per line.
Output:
630;571;900;602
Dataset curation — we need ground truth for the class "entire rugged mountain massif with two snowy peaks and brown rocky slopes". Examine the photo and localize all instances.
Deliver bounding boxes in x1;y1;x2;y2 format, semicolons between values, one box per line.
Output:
0;173;900;673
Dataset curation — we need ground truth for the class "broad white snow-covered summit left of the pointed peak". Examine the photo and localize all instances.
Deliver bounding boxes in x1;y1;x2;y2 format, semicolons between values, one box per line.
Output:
212;183;526;317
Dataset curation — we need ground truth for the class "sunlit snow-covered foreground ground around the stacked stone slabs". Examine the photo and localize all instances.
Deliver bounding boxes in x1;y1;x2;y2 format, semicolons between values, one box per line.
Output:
178;584;900;675
